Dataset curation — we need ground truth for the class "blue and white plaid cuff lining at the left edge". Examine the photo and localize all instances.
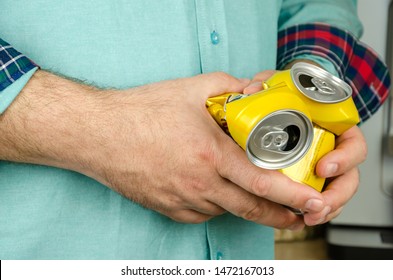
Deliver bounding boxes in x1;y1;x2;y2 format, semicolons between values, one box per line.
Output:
0;39;37;91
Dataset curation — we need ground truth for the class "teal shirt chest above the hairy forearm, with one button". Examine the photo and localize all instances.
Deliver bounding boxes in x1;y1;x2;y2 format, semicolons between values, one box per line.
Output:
0;0;278;88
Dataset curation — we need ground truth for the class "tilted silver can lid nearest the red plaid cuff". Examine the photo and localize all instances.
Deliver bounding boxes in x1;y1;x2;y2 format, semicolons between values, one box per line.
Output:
290;62;352;103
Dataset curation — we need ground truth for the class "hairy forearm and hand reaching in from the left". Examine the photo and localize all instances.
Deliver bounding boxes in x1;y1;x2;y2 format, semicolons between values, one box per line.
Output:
0;71;328;229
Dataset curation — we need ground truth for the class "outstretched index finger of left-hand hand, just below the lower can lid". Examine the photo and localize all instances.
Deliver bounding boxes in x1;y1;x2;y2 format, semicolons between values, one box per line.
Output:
216;140;325;212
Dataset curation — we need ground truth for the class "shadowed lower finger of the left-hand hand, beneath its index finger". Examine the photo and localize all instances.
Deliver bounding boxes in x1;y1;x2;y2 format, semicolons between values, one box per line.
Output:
209;177;304;230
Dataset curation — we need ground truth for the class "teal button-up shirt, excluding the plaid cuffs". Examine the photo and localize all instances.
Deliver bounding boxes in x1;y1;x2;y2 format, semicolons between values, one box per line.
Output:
0;0;361;259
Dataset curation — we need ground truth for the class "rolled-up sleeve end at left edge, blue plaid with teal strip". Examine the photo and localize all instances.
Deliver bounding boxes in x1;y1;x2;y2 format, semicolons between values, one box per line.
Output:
0;39;38;114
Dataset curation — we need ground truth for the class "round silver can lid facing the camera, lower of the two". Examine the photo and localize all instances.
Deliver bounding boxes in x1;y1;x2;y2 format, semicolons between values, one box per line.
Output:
246;110;314;169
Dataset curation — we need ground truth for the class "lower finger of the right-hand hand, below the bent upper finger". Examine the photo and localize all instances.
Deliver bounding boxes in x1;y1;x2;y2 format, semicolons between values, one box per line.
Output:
304;168;359;226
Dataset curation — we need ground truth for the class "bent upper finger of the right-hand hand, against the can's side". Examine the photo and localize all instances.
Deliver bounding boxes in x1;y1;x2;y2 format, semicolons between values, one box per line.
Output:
316;126;367;178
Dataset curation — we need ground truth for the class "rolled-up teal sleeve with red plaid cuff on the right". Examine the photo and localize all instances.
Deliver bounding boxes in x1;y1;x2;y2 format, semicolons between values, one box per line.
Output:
277;0;391;122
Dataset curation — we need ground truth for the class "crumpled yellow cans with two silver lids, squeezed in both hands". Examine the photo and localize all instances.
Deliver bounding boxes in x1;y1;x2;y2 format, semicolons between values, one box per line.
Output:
206;63;360;191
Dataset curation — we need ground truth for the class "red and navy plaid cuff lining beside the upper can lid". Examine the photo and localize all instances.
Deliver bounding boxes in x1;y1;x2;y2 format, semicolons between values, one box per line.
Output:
277;23;390;122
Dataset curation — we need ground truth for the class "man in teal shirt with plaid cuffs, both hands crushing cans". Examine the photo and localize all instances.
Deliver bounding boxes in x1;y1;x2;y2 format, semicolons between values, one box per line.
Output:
0;0;388;259
